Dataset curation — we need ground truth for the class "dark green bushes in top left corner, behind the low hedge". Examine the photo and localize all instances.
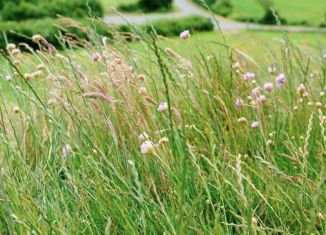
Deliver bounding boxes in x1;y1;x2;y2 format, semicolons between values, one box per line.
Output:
0;0;103;21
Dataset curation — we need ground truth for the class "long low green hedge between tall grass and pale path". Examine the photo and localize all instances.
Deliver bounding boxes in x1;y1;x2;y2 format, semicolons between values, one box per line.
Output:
0;16;214;48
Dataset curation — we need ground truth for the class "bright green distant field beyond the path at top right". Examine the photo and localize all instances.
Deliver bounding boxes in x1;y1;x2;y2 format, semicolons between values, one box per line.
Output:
230;0;326;25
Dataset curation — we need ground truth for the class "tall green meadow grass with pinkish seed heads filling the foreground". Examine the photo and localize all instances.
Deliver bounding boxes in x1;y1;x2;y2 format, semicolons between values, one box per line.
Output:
0;22;326;234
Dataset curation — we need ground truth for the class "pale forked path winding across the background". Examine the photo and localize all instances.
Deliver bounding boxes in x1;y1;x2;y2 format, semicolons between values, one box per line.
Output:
104;0;326;33
